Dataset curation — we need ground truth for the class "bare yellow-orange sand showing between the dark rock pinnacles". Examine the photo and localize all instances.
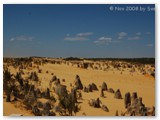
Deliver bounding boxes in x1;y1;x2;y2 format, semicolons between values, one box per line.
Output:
3;64;155;116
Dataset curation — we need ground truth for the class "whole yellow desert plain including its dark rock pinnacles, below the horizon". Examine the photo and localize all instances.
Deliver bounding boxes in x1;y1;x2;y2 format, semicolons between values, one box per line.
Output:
3;57;156;116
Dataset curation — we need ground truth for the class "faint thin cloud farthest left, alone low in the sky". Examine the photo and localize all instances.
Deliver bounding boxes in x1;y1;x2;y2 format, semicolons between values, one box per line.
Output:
10;35;33;42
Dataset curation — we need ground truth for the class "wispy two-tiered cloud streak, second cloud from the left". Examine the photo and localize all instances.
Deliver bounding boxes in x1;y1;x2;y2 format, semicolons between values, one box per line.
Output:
64;32;93;41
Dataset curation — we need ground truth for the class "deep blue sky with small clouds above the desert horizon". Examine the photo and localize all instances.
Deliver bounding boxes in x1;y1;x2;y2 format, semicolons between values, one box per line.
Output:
3;4;155;58
